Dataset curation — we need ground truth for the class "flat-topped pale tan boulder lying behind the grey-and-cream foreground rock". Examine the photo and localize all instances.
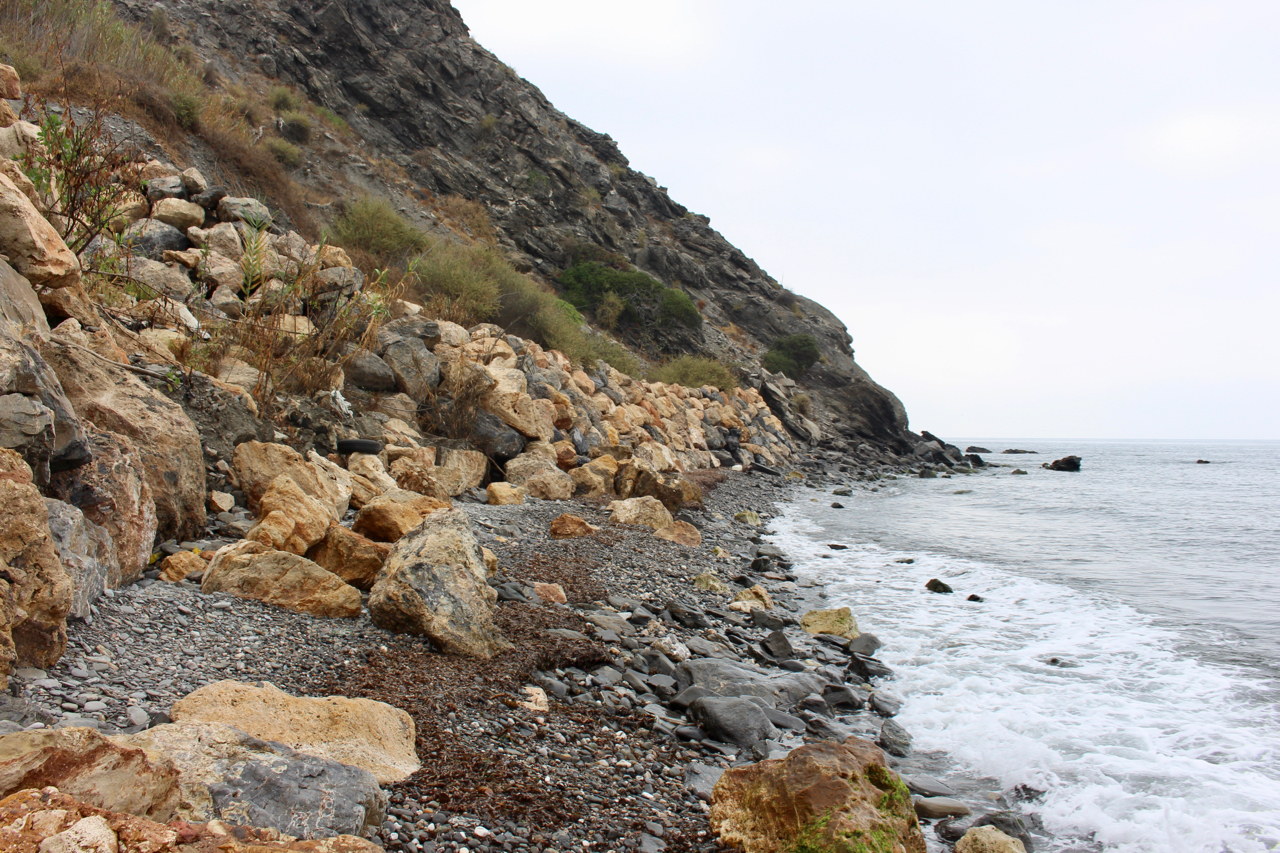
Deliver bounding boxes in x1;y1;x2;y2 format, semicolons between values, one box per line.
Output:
169;681;421;785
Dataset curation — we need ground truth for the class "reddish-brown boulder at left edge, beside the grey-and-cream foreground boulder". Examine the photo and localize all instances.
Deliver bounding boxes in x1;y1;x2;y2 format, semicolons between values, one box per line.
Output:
0;727;178;819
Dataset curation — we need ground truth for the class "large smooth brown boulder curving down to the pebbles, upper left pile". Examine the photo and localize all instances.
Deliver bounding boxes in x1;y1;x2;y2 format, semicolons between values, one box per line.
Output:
44;342;205;539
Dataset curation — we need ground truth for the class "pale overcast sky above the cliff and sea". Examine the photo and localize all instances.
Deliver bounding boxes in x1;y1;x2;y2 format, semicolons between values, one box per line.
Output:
454;0;1280;439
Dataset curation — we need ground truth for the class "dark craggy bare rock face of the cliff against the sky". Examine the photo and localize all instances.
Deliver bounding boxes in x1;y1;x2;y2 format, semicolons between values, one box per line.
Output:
116;0;910;450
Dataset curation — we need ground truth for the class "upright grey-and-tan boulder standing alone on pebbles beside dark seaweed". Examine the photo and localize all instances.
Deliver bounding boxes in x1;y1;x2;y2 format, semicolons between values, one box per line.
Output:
369;508;511;658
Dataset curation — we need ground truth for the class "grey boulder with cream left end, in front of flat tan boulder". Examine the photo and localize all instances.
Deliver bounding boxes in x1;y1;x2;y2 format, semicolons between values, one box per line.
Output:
114;722;387;838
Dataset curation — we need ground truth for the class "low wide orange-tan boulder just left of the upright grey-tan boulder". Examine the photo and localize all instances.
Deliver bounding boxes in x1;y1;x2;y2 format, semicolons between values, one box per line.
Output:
200;539;360;619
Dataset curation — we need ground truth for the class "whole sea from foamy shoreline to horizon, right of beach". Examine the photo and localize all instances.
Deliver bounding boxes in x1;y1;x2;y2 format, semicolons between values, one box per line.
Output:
772;439;1280;853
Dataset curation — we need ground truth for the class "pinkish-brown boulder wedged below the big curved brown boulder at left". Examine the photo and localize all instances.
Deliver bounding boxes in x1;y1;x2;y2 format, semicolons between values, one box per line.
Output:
50;425;159;589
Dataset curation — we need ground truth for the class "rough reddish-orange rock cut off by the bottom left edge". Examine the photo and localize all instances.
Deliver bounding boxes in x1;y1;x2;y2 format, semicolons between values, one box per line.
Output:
0;788;383;853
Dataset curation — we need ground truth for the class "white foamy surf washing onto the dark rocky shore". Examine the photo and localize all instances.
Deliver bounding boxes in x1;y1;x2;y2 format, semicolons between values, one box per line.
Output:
772;503;1280;853
